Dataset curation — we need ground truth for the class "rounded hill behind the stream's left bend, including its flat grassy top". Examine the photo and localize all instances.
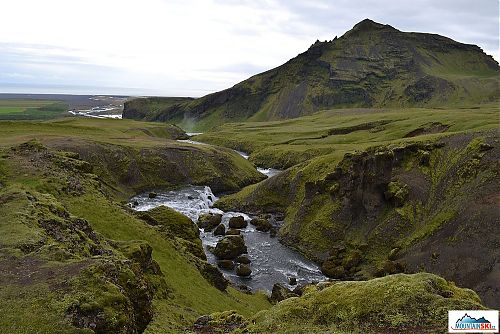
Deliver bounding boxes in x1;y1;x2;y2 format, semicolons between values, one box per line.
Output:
0;119;263;199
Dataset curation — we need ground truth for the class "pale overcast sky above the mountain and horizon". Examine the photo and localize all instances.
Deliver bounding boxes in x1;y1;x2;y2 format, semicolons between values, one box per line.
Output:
0;0;500;96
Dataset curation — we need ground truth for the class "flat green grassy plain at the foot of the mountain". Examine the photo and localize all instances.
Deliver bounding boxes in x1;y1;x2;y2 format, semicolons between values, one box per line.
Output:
196;103;500;168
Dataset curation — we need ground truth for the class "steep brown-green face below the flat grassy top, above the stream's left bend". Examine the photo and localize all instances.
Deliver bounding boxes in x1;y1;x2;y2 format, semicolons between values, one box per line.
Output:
50;141;264;196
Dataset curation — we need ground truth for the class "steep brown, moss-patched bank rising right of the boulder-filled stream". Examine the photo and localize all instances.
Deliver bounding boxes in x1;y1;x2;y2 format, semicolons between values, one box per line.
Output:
220;131;499;305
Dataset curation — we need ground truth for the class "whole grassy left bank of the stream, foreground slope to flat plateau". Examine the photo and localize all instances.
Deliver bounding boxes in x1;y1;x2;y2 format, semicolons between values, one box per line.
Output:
0;119;270;333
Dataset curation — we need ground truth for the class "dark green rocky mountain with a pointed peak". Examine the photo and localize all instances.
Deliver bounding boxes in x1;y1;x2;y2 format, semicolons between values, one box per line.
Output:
123;19;500;129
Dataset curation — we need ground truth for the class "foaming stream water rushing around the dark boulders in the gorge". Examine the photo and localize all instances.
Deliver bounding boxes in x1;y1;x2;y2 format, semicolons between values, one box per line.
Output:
131;186;325;291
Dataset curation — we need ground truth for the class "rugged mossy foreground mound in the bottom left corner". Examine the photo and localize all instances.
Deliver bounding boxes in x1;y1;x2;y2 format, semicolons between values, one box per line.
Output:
0;184;165;333
